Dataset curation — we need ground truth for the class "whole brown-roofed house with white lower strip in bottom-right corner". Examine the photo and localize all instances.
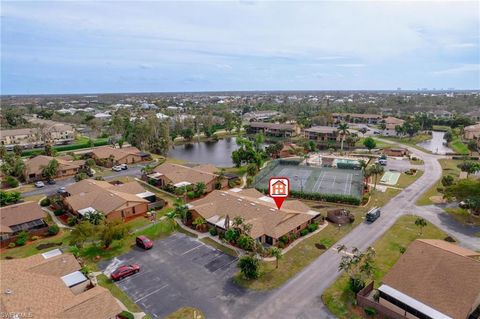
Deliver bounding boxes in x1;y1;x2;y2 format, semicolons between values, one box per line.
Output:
360;239;480;319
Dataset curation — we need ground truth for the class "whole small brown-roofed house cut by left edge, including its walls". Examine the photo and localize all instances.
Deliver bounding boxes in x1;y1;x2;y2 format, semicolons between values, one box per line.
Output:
0;202;47;247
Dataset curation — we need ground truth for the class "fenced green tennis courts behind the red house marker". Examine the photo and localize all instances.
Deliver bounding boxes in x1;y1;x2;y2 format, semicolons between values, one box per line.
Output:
255;164;363;197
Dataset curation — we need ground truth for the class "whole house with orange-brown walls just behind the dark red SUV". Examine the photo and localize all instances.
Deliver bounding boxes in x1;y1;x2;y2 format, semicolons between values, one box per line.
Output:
64;179;155;220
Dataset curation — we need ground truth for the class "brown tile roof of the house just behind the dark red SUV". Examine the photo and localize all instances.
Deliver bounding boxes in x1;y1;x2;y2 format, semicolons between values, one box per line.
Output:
65;179;148;215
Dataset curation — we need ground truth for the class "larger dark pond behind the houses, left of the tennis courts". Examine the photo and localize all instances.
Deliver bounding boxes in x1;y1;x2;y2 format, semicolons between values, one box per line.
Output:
168;137;238;167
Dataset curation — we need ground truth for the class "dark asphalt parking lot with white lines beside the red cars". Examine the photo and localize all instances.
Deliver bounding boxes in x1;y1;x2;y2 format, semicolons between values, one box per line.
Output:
100;233;264;318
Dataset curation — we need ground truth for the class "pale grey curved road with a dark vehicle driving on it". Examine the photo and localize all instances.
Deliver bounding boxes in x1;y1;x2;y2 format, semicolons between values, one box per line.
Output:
245;141;480;319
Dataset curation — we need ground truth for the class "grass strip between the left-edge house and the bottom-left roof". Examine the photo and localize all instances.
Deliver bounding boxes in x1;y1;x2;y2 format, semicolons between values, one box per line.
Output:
1;230;70;259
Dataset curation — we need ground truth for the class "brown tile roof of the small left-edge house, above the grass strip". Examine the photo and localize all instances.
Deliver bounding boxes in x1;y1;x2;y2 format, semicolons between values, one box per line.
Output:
0;202;46;232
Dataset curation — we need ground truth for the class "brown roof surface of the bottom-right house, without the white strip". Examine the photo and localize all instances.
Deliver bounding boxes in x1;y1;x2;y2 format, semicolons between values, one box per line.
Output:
383;240;480;319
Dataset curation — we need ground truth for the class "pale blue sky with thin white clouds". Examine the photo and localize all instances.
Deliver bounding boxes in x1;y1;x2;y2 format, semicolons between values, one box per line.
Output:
0;1;480;94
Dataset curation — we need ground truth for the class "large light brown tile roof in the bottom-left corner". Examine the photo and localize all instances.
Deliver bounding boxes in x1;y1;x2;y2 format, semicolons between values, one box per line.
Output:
0;254;122;319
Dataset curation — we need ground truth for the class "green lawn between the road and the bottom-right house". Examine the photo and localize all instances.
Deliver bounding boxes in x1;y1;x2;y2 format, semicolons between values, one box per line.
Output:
322;215;447;319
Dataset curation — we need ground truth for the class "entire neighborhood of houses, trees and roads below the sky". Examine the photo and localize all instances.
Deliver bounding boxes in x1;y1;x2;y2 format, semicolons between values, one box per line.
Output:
0;92;480;319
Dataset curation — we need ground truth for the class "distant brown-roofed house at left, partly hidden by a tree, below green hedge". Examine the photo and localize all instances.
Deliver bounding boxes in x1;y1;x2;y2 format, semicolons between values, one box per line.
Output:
23;155;85;183
